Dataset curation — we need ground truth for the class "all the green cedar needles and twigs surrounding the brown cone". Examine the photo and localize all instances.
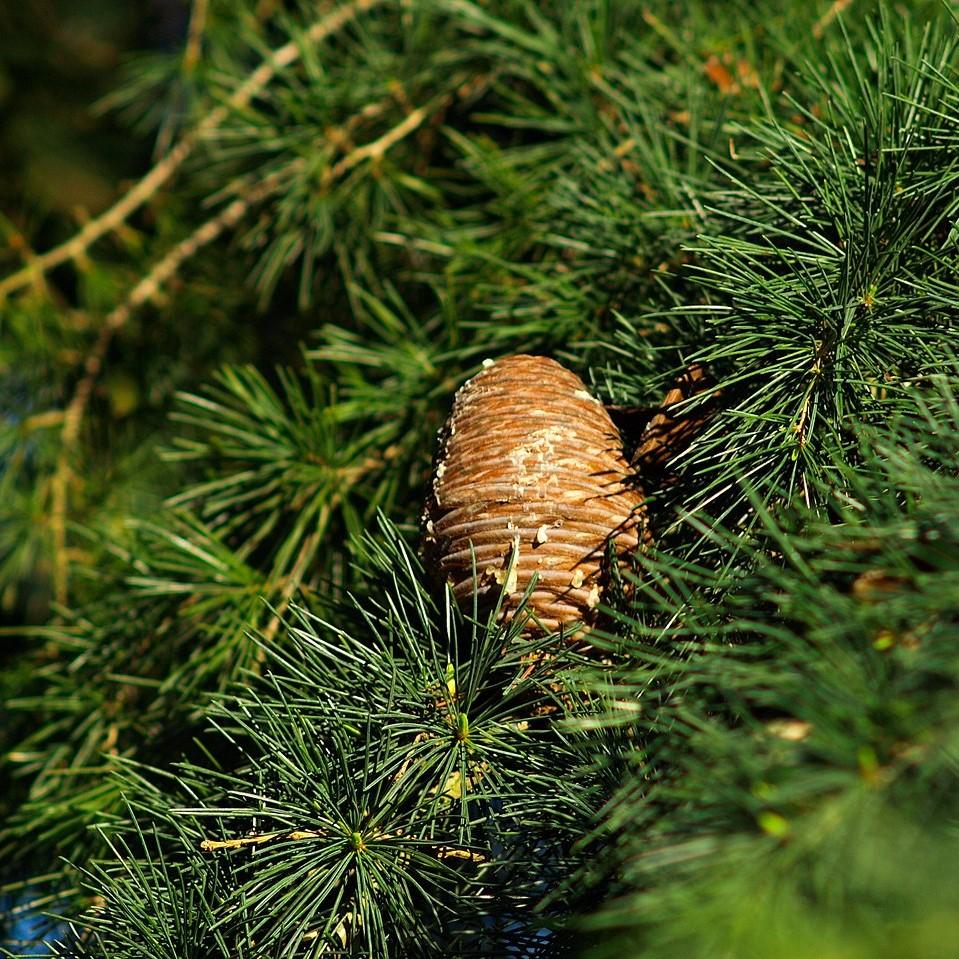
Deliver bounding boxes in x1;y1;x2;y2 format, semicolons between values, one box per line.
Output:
0;0;959;959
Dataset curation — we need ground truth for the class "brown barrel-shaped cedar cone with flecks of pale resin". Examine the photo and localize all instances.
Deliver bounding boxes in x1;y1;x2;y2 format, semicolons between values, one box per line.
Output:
424;356;646;632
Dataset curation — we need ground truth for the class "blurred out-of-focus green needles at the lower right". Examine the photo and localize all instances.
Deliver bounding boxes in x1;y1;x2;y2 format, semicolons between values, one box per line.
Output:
579;374;959;957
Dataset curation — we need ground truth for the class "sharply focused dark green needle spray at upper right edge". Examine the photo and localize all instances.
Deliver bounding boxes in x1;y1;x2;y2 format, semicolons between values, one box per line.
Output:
668;17;959;520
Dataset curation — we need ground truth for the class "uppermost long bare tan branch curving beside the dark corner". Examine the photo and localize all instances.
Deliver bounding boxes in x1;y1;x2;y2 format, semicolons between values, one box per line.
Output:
0;0;385;301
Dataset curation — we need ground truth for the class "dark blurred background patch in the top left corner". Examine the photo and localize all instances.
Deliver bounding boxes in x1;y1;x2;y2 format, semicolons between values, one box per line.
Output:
0;2;155;223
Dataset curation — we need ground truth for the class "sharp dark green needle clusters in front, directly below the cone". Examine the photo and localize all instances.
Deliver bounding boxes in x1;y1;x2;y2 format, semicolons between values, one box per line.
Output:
43;526;595;957
